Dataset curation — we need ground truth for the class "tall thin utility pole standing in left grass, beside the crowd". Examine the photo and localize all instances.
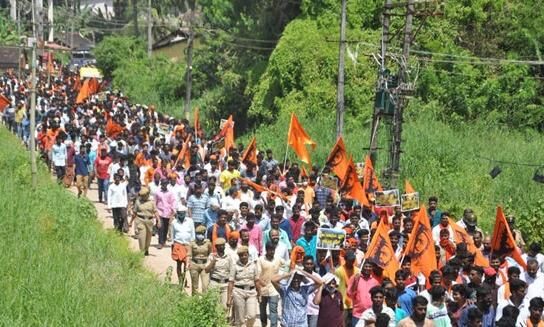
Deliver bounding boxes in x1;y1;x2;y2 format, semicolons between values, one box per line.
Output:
30;0;38;190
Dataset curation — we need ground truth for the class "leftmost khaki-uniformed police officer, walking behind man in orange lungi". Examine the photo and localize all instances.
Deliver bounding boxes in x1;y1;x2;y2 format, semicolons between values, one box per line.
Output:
130;187;158;255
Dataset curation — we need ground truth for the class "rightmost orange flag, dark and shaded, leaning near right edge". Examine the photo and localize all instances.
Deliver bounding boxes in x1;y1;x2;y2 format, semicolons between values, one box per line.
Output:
491;207;527;269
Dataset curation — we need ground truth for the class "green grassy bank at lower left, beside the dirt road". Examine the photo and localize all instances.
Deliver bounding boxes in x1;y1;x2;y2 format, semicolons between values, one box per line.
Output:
0;128;225;326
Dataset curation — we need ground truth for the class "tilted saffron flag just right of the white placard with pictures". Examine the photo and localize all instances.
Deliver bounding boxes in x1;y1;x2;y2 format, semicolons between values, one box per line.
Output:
365;221;399;280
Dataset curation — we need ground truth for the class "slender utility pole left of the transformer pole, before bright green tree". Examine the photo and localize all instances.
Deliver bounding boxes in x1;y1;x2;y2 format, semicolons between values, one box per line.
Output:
336;0;347;138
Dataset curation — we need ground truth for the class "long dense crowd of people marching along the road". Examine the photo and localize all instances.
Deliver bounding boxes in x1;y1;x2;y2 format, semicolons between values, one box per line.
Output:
0;64;544;327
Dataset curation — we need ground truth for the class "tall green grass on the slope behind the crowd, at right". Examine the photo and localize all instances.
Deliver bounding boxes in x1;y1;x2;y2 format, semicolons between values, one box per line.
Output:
239;106;544;239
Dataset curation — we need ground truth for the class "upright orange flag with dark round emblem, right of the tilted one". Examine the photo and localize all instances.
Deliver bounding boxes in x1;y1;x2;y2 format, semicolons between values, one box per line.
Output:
403;205;436;277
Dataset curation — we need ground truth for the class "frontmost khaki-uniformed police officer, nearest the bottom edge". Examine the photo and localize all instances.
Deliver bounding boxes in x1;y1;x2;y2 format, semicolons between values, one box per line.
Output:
227;245;260;327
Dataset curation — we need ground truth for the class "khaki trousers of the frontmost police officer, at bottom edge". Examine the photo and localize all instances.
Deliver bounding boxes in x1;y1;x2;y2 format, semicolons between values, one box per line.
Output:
232;286;259;327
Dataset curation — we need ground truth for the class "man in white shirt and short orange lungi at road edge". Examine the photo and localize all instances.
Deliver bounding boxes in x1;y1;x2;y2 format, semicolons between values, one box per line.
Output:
172;204;196;285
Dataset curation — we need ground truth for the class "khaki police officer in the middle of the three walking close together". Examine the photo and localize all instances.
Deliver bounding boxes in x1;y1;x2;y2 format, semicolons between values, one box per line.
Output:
206;237;231;310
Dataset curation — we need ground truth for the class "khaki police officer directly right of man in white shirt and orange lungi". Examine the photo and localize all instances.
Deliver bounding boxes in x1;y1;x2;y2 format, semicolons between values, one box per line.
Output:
187;225;212;294
